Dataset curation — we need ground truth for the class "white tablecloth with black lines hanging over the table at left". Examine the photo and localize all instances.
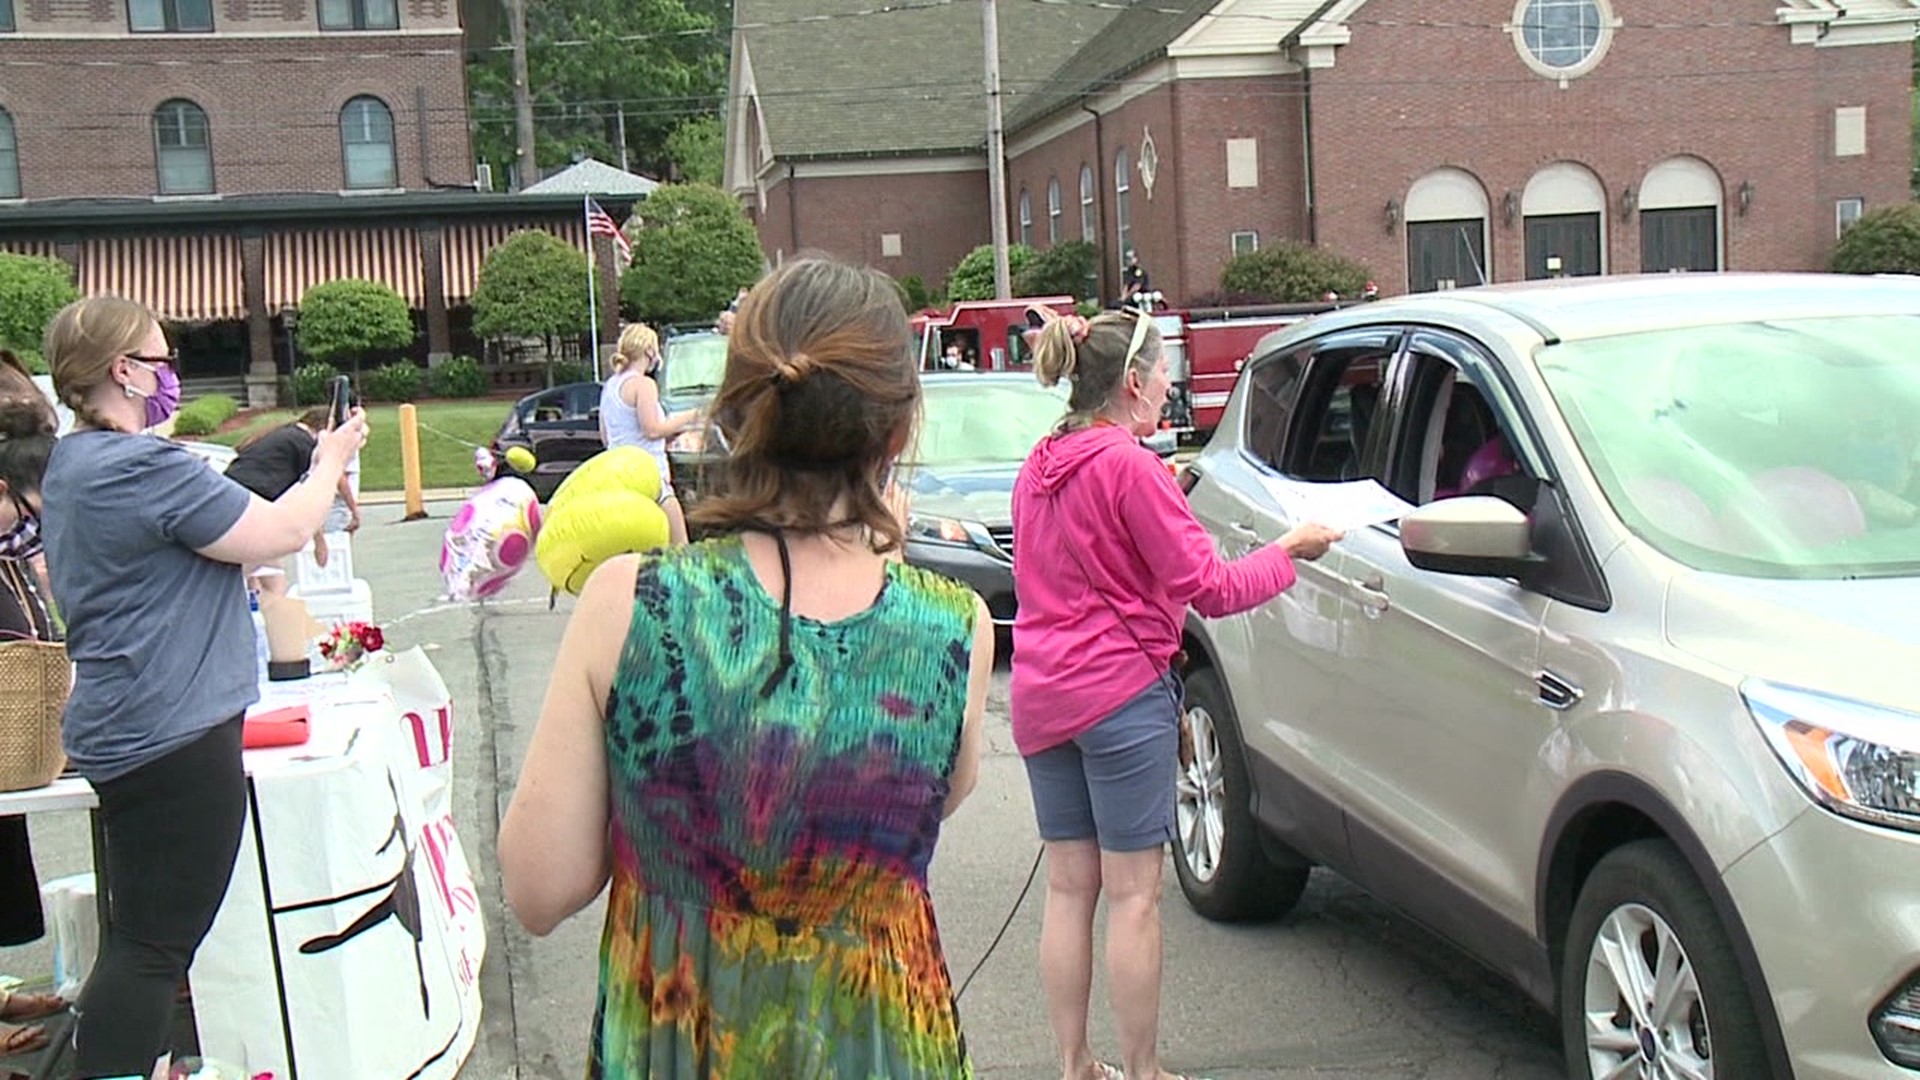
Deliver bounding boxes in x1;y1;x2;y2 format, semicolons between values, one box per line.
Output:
0;657;486;1080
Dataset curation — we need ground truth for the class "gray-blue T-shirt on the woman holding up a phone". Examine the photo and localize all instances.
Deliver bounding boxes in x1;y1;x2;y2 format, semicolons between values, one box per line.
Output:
42;430;259;780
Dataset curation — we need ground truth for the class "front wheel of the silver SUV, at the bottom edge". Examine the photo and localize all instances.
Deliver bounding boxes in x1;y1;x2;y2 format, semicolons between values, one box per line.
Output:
1561;840;1772;1080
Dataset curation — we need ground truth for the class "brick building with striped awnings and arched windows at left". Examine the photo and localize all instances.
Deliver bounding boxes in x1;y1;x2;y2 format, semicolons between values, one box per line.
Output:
0;0;630;404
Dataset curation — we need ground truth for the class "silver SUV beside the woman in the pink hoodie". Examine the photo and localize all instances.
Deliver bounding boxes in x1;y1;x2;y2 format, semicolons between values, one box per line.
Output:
1175;275;1920;1080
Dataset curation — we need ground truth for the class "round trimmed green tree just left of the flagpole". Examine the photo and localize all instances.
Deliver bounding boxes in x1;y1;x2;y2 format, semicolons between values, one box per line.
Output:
472;229;589;382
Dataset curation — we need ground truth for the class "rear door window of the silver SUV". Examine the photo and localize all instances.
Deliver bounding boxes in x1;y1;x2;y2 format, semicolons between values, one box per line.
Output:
1267;329;1400;482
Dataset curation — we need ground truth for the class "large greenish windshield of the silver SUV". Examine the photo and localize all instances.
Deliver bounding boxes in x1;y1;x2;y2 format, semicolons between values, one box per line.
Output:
1538;315;1920;578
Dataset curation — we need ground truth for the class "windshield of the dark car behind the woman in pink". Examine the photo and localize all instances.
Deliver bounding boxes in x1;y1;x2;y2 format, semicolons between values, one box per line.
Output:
910;377;1068;467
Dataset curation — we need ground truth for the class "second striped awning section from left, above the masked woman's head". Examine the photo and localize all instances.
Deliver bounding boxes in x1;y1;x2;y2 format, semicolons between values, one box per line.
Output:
79;234;246;323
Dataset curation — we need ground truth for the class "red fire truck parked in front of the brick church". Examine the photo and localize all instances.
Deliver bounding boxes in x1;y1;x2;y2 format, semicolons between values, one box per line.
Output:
912;296;1348;440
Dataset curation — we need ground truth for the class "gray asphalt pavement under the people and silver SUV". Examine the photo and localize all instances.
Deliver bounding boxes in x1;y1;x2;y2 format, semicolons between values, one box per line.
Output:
15;502;1565;1080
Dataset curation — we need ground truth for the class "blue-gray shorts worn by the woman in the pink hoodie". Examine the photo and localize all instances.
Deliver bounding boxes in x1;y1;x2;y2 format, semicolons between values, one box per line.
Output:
1025;673;1183;851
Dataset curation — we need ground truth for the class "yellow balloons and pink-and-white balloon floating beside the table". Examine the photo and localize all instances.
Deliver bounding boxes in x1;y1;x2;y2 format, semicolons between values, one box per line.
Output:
440;446;670;600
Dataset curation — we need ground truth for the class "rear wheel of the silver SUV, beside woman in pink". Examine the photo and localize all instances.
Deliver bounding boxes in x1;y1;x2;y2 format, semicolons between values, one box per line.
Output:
1173;671;1311;922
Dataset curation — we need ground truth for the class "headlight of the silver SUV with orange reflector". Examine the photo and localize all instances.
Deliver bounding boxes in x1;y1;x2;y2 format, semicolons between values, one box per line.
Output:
1740;678;1920;832
